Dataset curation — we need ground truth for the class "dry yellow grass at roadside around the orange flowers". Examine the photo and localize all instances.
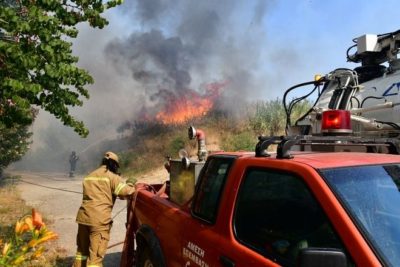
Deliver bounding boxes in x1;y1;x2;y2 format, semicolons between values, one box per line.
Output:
0;177;72;267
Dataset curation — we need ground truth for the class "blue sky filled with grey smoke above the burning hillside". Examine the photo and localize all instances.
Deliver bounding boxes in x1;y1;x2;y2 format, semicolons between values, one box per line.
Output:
11;0;400;172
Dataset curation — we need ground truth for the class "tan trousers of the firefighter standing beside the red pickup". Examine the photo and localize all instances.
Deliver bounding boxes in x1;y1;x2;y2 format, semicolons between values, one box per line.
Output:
73;224;111;267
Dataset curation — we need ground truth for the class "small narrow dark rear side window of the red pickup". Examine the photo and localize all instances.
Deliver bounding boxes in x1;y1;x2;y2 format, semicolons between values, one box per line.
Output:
192;157;234;223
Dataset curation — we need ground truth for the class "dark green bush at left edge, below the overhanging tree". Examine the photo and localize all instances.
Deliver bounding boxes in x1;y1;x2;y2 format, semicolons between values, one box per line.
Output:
0;122;32;177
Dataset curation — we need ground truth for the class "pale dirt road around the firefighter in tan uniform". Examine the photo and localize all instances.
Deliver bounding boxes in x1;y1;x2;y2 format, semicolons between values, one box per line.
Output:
11;169;168;267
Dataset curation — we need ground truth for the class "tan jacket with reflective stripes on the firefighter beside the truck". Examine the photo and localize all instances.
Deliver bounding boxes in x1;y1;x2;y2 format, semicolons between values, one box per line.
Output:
76;165;135;226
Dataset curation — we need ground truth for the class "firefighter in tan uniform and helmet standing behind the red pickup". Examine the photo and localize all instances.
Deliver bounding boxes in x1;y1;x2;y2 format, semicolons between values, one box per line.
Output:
73;152;135;267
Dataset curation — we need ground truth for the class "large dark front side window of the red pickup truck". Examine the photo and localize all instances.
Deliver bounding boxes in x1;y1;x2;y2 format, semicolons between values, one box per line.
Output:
234;169;347;266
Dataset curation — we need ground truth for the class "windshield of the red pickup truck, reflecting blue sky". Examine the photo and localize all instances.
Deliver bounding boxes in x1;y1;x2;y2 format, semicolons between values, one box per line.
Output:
321;164;400;266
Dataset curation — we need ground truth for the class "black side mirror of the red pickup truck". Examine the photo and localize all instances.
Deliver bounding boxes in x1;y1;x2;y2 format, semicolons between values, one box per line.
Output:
297;248;347;267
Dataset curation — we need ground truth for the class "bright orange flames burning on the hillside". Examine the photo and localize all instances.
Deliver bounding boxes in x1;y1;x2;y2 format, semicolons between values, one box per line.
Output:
156;82;226;124
